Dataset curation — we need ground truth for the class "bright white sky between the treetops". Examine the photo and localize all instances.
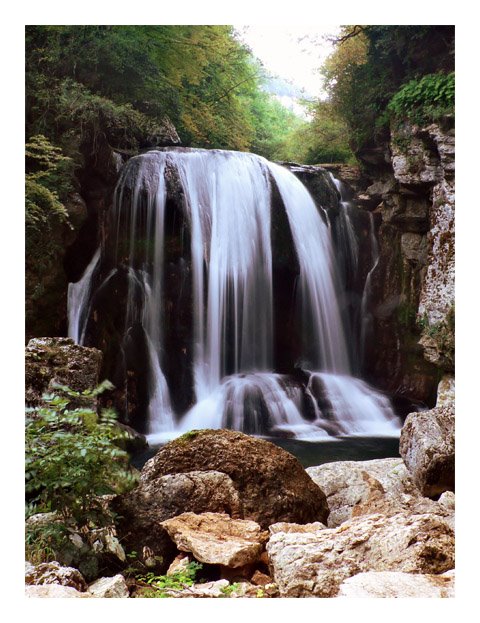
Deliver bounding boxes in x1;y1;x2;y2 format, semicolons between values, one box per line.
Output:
235;24;340;97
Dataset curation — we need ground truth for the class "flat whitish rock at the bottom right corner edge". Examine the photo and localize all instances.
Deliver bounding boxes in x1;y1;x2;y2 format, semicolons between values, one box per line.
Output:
337;571;455;598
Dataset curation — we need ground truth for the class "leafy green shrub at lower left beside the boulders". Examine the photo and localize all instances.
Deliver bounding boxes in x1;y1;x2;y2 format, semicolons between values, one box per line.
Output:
25;381;135;526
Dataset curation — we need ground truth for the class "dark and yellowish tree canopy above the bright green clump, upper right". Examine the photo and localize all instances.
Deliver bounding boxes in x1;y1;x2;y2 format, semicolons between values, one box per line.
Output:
323;26;455;151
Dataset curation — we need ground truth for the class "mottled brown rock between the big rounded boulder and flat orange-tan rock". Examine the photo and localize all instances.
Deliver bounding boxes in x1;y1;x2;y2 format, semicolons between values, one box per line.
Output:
111;471;241;571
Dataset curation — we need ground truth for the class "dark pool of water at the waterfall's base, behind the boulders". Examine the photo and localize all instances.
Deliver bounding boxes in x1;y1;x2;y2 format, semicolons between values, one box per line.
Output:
132;437;400;469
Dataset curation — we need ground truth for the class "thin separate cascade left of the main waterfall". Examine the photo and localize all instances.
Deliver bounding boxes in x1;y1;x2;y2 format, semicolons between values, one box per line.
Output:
67;247;101;344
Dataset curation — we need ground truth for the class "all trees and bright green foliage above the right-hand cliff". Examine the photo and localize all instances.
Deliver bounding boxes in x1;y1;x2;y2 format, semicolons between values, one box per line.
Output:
322;26;455;152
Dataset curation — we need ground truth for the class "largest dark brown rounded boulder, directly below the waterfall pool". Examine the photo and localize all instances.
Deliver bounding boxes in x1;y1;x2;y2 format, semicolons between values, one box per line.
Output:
140;430;328;528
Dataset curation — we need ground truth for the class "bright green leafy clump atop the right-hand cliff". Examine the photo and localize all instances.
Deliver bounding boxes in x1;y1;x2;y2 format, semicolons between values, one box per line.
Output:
387;72;455;124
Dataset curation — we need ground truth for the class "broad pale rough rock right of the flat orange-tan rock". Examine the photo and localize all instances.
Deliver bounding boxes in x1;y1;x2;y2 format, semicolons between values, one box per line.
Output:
267;513;454;597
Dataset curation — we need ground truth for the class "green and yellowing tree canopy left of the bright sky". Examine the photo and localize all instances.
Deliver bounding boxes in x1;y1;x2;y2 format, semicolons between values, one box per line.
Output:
26;25;304;155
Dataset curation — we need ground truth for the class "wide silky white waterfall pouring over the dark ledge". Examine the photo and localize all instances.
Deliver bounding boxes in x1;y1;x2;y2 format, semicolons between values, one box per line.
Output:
69;148;399;443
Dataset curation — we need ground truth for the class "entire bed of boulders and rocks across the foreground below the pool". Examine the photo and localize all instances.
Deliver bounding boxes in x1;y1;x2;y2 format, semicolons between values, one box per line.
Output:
25;390;455;598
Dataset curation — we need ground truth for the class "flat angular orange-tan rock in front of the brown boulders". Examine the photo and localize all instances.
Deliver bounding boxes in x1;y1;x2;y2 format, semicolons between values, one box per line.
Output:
162;513;267;568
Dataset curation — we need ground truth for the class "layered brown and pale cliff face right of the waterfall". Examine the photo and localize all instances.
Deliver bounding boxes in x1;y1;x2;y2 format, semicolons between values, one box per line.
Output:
359;119;455;406
